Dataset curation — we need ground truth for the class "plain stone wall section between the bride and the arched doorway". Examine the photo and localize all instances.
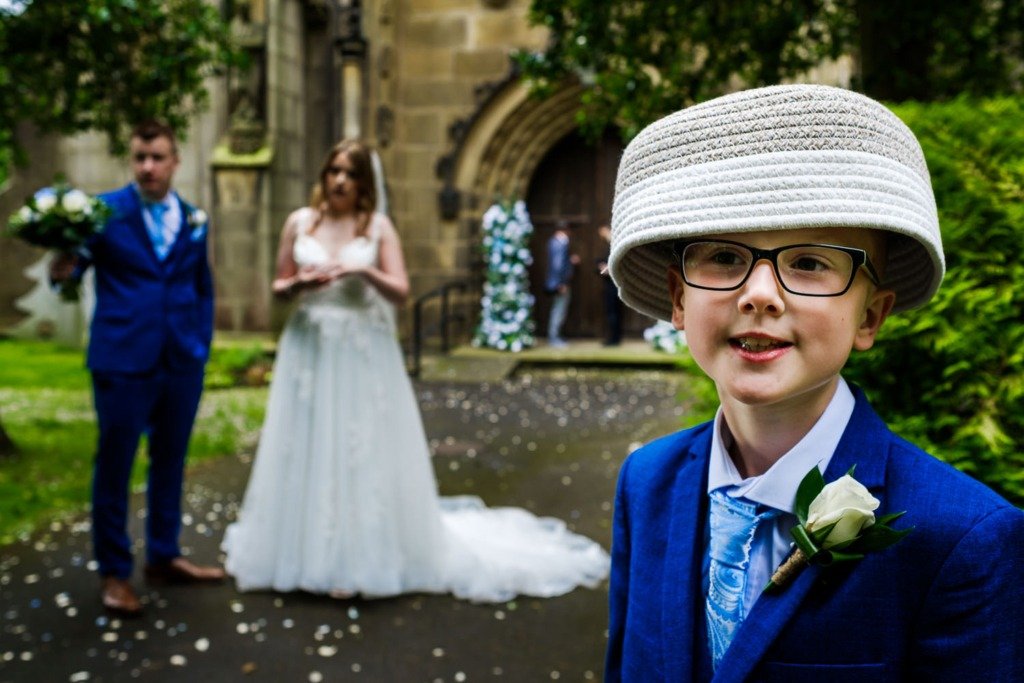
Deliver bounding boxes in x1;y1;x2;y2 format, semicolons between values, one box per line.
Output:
377;0;545;299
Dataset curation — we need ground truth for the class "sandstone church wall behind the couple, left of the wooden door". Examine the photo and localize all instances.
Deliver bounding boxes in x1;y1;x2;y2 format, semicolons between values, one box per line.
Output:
0;0;849;338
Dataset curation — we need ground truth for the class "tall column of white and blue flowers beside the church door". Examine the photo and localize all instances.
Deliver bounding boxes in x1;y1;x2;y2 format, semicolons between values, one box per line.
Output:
473;194;536;352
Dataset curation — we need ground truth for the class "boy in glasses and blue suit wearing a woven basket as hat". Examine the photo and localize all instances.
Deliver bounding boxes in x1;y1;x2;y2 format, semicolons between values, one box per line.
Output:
606;85;1024;682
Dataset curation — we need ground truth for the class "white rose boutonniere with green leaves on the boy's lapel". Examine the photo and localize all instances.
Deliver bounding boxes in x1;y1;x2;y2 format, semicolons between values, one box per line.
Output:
765;467;913;592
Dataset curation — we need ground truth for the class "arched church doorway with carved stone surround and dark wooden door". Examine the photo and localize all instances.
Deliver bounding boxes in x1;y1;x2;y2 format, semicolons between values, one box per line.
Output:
437;74;651;339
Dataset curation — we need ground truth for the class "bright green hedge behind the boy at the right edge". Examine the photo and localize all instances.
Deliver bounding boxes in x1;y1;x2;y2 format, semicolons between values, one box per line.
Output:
845;98;1024;505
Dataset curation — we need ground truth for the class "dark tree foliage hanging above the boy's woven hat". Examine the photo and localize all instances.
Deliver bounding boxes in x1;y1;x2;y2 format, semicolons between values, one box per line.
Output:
517;0;1024;139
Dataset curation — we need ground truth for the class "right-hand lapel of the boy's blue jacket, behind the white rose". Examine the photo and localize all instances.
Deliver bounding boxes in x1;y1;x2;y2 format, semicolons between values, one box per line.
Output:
714;386;891;683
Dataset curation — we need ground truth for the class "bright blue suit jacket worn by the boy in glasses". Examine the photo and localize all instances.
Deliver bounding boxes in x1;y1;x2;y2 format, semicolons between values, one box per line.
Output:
606;390;1024;683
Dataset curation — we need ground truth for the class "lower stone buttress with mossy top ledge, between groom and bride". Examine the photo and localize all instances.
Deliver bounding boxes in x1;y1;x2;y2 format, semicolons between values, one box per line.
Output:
210;144;274;331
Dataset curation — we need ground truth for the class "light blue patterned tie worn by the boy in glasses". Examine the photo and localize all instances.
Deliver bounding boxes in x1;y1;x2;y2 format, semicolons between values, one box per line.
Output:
705;489;779;669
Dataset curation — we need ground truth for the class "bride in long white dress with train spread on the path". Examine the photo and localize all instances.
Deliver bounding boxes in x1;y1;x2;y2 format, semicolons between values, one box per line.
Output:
223;141;609;602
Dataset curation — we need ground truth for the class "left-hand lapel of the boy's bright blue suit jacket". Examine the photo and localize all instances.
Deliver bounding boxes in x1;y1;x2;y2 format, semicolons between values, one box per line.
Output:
662;429;712;681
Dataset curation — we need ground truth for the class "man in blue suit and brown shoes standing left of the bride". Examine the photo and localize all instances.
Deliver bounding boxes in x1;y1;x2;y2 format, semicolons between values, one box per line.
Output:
51;122;223;615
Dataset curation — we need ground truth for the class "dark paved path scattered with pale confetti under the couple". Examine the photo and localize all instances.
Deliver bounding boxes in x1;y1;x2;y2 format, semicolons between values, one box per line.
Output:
0;369;682;683
